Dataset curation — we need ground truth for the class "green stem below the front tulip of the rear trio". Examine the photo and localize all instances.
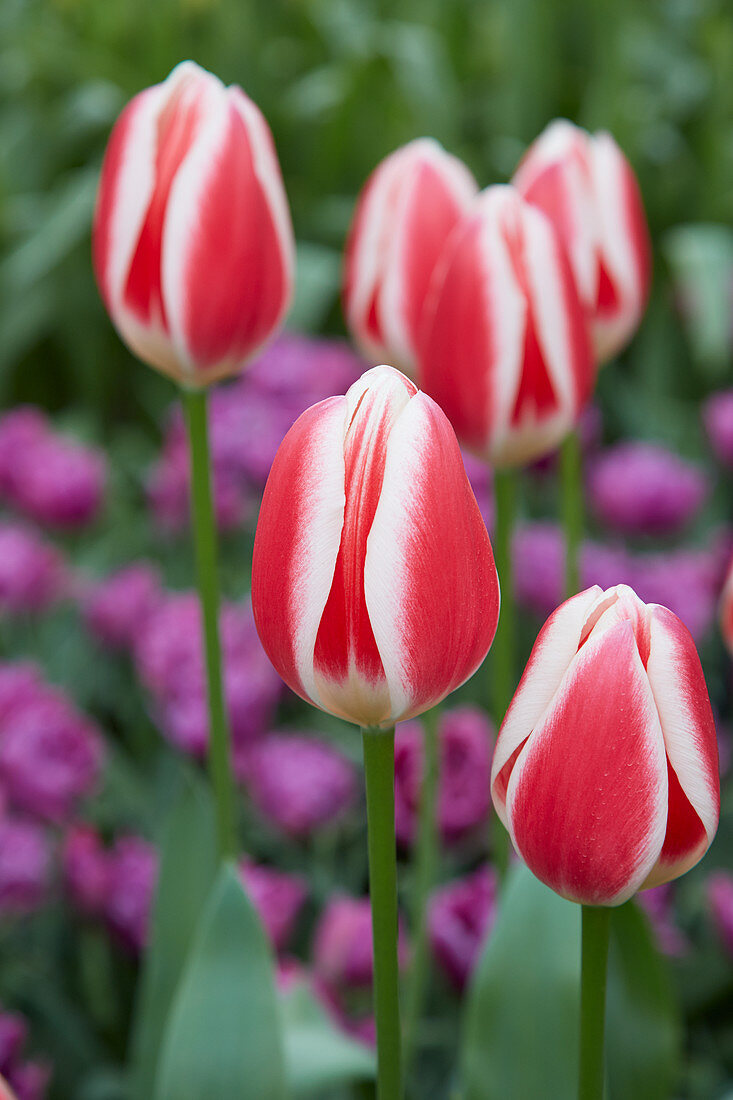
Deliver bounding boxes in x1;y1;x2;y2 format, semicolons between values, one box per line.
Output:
492;470;517;880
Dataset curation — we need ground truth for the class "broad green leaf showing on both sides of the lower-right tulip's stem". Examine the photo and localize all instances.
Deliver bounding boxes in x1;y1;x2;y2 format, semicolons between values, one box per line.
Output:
461;866;679;1100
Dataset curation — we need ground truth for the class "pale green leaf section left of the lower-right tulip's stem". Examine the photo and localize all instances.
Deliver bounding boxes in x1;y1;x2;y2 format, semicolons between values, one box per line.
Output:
461;866;580;1100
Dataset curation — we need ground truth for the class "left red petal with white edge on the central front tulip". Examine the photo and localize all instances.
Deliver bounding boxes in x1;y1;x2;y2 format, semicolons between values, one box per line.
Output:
252;397;347;706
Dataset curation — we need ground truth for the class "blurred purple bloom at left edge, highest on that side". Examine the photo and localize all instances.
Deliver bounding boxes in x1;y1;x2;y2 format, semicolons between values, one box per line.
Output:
0;407;107;528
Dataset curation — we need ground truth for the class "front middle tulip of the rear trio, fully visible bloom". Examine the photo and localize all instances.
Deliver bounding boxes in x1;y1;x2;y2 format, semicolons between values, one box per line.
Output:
420;186;595;466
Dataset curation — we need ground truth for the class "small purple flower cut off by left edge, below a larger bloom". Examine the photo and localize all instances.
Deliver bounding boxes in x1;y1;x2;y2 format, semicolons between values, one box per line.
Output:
0;817;51;913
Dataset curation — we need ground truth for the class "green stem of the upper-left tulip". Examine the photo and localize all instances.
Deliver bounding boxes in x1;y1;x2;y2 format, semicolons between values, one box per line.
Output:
183;389;237;859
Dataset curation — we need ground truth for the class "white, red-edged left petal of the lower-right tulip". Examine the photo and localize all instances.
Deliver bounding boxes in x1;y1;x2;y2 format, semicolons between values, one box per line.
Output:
491;585;603;825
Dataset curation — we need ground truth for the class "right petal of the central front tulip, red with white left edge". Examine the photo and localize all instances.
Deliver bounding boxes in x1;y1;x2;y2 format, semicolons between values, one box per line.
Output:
364;393;499;722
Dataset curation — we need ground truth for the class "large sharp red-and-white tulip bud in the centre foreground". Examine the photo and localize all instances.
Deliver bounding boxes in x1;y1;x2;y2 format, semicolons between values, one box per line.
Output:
252;366;499;728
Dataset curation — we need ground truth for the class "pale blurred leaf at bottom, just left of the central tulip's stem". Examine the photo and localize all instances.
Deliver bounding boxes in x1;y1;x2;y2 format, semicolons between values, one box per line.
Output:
280;985;376;1097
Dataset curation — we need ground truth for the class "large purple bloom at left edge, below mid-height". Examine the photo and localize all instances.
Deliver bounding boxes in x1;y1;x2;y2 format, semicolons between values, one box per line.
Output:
0;684;102;823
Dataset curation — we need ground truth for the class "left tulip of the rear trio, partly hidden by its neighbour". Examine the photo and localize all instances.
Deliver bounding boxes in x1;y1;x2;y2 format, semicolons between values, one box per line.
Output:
343;138;478;375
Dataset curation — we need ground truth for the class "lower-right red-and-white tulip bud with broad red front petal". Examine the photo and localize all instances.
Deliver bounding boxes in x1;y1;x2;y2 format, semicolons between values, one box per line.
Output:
491;584;720;905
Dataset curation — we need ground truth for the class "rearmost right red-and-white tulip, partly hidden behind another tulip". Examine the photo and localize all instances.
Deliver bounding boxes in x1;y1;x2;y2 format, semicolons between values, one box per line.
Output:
513;119;652;363
